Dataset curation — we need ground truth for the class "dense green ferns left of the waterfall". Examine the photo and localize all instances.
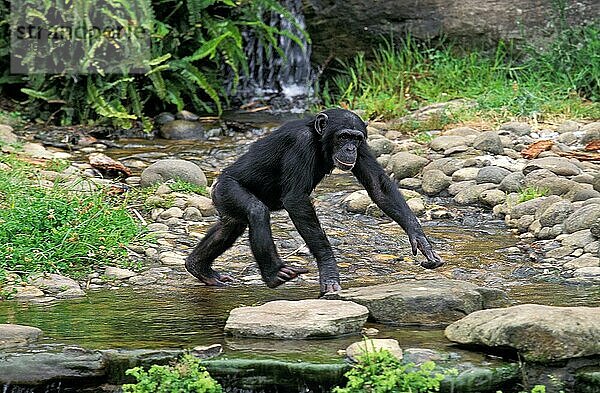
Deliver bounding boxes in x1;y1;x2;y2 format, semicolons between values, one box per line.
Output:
0;0;301;128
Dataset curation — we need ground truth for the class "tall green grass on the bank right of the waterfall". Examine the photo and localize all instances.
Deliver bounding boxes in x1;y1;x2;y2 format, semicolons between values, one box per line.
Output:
321;24;600;124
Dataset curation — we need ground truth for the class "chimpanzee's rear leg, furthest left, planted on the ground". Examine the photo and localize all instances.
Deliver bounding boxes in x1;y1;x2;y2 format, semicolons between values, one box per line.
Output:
185;216;246;286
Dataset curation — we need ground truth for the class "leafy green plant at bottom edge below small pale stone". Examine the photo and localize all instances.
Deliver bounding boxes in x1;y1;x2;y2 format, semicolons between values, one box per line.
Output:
333;350;444;393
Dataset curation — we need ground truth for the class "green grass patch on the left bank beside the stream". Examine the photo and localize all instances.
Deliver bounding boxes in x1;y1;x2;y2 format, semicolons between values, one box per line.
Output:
0;156;142;277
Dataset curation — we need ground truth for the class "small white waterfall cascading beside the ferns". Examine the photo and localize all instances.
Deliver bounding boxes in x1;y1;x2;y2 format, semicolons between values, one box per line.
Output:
238;0;313;111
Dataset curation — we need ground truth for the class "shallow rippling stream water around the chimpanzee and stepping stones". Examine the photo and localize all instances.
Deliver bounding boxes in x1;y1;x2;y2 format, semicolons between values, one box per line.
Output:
0;123;600;361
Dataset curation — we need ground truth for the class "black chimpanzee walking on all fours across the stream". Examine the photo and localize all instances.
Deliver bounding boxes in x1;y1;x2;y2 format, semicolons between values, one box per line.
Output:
185;109;444;294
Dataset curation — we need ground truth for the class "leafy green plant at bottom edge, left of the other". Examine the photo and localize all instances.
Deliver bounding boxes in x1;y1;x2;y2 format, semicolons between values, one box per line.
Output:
123;354;223;393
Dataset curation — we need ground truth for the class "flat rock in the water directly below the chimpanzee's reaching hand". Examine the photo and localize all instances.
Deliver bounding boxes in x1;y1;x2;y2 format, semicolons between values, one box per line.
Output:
326;279;508;326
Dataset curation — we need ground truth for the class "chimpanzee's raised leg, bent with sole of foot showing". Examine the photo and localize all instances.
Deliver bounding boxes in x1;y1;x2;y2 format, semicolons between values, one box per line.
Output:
215;178;308;288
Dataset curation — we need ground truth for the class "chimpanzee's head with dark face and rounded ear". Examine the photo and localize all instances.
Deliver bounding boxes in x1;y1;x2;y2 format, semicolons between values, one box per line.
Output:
314;109;367;171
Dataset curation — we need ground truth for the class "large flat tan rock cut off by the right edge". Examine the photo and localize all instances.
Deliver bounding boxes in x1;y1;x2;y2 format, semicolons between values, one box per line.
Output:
446;304;600;363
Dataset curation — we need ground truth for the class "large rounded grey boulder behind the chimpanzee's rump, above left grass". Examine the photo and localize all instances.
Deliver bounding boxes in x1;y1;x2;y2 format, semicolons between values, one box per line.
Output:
140;159;207;187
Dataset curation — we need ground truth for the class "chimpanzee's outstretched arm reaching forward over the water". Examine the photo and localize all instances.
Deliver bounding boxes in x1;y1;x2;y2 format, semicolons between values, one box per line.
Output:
352;144;444;269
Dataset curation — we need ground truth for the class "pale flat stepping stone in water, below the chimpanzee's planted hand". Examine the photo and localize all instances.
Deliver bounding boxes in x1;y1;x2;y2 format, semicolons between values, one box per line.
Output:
225;299;369;339
